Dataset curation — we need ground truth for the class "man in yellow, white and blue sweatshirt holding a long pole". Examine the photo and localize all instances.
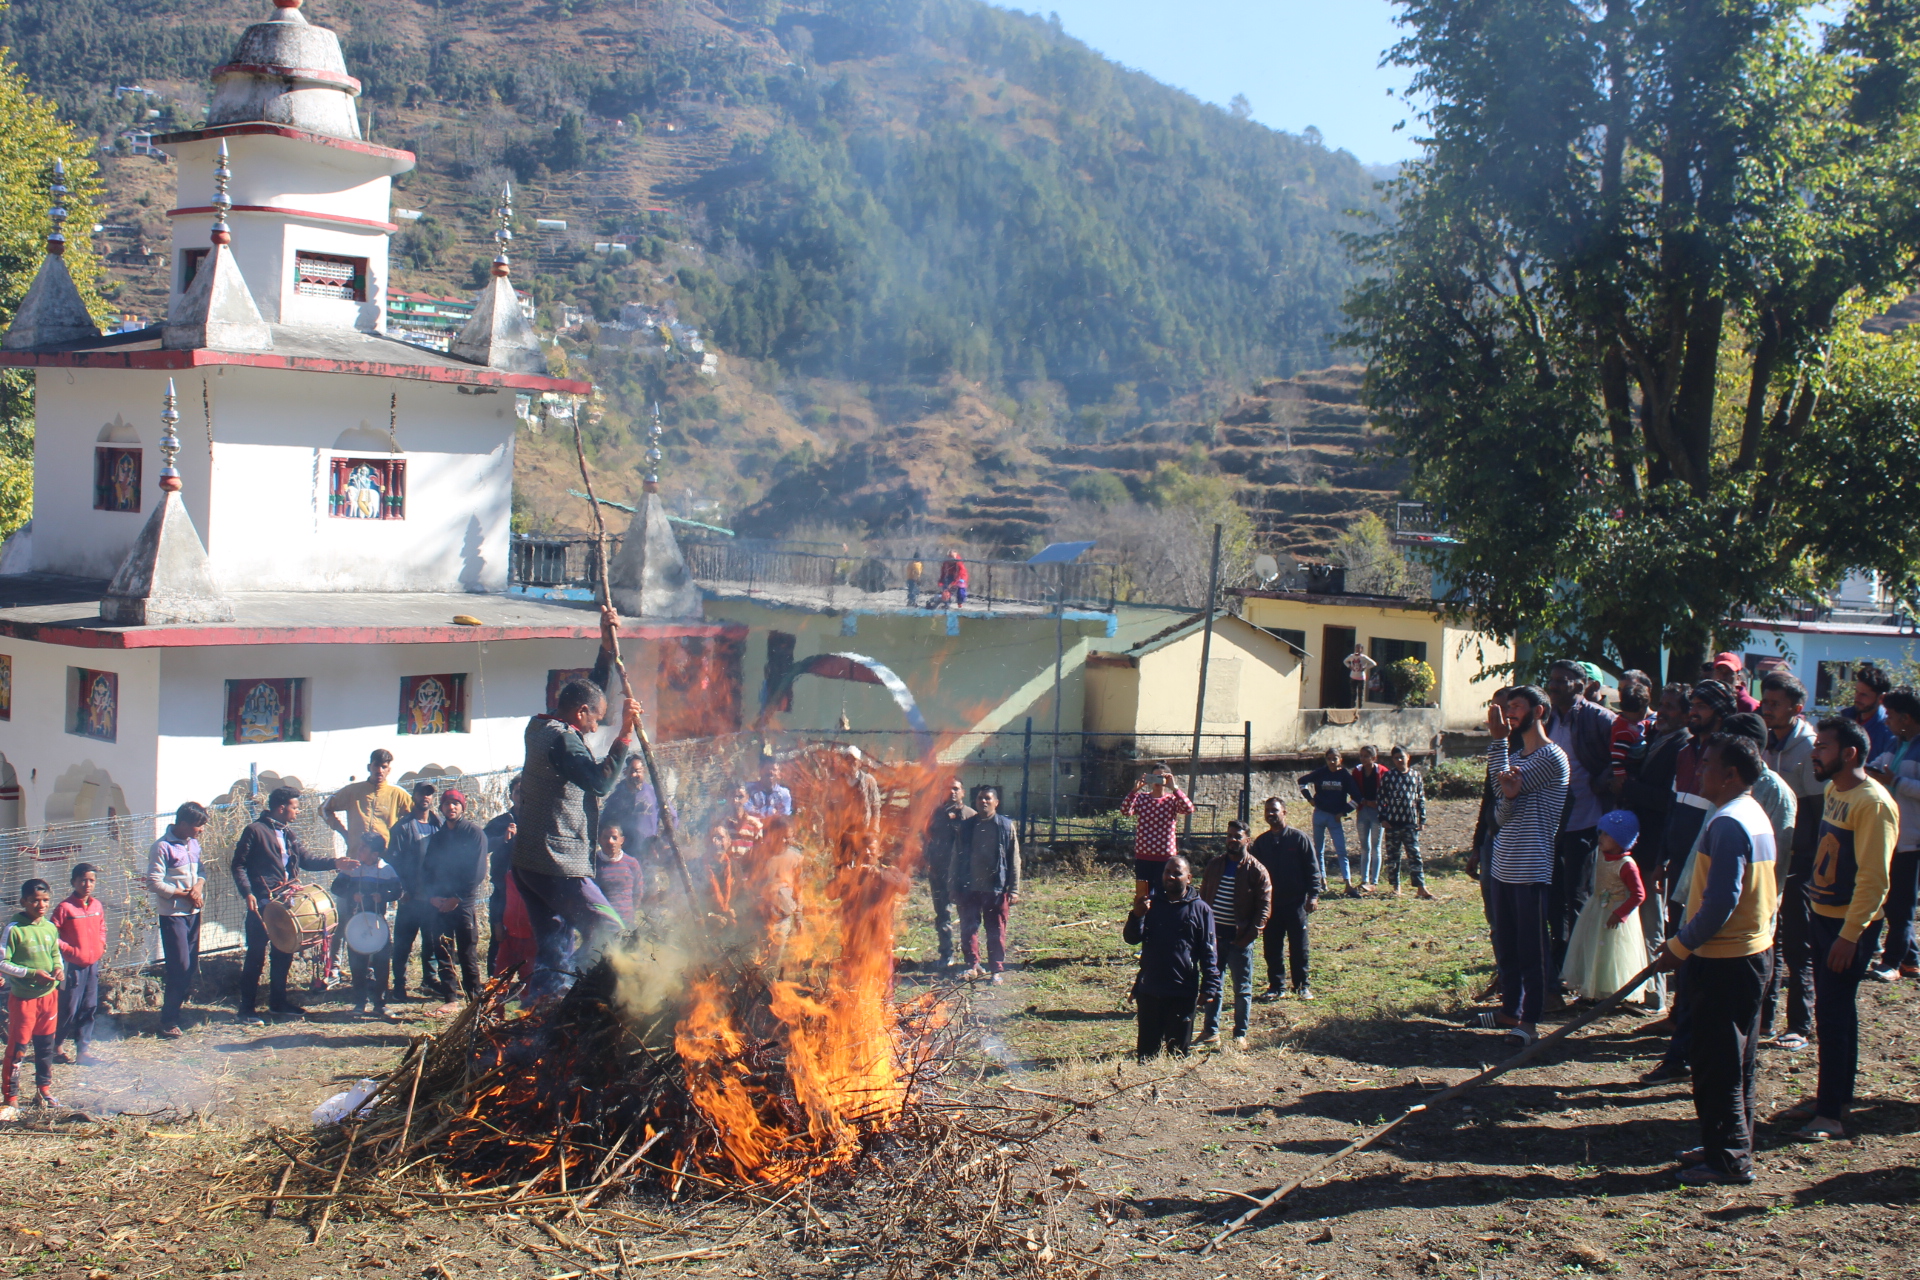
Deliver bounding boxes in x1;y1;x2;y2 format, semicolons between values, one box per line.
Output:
1659;733;1780;1186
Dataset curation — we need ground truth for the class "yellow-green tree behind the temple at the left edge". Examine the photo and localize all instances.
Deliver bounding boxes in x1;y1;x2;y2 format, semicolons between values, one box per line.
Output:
0;21;102;535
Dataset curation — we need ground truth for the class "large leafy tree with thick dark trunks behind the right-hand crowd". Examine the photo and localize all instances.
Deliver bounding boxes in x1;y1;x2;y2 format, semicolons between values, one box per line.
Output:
1348;0;1920;670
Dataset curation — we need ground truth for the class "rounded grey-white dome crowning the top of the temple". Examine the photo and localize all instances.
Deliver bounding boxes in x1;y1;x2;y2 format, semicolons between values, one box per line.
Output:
207;0;361;140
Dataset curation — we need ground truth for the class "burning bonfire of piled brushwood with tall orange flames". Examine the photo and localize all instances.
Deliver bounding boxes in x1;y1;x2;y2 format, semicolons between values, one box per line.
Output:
225;747;1098;1274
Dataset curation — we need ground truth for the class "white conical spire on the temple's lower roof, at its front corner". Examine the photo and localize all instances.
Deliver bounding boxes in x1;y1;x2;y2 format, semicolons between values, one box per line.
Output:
100;378;234;628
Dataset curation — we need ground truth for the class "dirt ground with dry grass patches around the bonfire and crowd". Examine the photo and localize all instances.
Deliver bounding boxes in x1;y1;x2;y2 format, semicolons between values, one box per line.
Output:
0;802;1920;1280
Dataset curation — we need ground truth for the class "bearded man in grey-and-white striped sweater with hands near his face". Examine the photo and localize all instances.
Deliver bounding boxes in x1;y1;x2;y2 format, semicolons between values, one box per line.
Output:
1486;685;1569;1040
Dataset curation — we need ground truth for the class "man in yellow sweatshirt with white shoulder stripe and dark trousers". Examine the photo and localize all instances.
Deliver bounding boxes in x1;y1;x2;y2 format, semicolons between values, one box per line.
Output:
1774;718;1901;1142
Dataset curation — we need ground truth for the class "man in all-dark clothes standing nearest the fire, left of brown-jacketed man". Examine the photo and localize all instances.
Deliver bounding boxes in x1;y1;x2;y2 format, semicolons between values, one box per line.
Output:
1121;854;1219;1063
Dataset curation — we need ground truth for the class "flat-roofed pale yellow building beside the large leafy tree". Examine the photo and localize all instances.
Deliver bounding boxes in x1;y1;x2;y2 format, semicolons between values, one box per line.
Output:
1233;589;1513;729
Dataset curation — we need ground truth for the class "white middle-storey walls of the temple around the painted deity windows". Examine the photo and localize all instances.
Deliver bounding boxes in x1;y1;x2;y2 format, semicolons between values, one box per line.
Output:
33;365;516;591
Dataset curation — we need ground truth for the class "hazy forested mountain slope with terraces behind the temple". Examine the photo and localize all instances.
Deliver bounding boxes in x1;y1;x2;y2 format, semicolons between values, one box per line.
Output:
0;0;1377;537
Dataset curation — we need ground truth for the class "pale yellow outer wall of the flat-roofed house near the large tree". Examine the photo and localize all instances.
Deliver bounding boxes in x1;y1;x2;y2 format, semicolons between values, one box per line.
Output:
1244;595;1513;727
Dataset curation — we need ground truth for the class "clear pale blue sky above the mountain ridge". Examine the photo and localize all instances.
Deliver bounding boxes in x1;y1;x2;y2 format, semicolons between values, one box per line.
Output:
1000;0;1415;165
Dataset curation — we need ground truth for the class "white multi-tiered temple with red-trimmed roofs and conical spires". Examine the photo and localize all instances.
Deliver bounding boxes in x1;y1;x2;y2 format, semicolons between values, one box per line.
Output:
0;0;741;827
